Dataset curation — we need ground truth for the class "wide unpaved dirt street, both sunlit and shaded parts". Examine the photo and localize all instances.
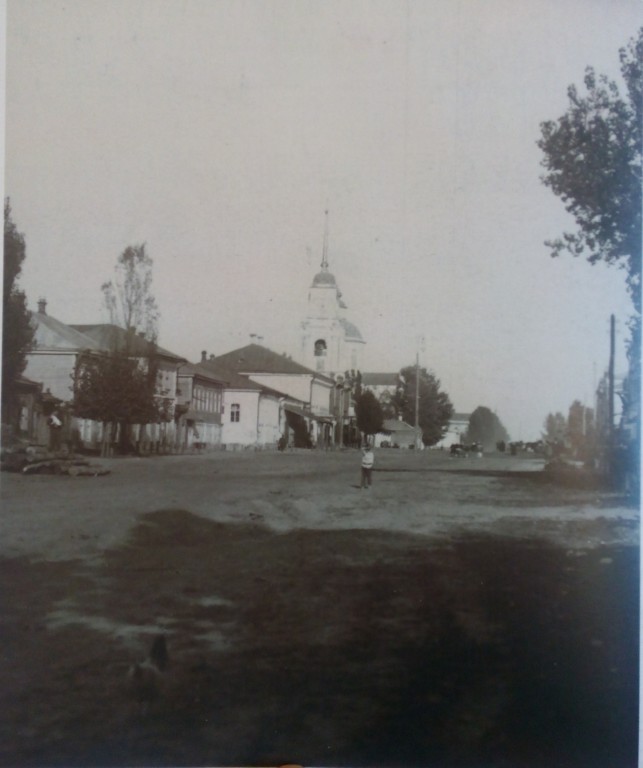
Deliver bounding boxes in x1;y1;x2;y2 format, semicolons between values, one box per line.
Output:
0;449;639;768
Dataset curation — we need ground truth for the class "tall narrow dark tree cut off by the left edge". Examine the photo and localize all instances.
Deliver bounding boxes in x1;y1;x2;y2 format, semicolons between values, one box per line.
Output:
2;198;34;421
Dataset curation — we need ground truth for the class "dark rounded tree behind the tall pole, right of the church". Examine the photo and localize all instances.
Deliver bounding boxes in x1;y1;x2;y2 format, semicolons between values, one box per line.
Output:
392;365;453;445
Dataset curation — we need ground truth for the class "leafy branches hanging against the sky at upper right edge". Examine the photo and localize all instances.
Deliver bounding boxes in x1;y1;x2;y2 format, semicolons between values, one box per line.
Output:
538;28;643;312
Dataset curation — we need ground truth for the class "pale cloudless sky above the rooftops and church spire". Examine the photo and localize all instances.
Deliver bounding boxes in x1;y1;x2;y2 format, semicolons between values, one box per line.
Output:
4;0;643;439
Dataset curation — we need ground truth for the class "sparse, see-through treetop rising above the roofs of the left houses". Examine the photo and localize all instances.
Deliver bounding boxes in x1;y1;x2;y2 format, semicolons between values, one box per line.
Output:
101;243;159;340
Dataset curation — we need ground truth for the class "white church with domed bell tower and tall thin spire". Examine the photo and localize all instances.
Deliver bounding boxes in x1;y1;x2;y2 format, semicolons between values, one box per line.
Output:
299;211;366;378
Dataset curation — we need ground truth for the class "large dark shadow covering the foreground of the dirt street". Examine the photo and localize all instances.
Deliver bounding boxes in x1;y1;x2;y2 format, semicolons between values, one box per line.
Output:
0;510;639;768
